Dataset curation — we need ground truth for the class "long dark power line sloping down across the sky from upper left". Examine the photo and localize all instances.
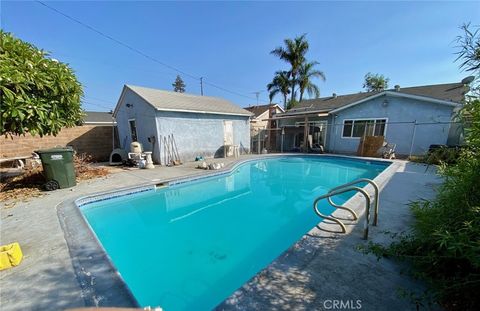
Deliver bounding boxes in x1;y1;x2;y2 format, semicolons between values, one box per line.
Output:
35;0;266;103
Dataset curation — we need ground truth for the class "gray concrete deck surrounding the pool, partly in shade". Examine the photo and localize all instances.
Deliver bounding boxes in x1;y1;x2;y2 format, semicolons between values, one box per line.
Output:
0;156;441;310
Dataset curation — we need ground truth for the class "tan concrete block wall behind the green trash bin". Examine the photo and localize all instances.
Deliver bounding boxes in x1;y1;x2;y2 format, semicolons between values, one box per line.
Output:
0;125;112;161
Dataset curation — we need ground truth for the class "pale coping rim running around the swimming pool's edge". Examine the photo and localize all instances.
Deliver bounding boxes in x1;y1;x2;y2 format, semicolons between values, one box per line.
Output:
57;153;400;309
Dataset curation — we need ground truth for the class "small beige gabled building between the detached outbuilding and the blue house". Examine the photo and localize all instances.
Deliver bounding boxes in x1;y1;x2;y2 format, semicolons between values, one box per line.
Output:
245;104;285;152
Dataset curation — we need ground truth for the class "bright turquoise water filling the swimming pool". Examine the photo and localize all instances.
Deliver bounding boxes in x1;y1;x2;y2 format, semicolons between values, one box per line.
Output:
81;157;388;311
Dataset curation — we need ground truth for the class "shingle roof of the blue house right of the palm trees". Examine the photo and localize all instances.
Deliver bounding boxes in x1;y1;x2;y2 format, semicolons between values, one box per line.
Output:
286;83;468;114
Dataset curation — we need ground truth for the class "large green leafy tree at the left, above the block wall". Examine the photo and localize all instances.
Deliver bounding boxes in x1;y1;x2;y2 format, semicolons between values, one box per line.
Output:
0;30;83;136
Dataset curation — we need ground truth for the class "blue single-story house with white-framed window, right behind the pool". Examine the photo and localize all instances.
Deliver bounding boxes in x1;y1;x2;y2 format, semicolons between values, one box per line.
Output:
273;79;469;155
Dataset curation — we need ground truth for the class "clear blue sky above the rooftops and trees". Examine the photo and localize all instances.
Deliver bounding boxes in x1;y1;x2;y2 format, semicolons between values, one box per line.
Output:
1;1;480;111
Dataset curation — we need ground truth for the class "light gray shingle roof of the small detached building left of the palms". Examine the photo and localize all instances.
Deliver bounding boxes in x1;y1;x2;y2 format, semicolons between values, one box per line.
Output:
126;85;252;116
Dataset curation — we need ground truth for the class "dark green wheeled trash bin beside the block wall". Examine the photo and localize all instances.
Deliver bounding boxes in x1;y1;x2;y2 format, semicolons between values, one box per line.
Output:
35;148;77;191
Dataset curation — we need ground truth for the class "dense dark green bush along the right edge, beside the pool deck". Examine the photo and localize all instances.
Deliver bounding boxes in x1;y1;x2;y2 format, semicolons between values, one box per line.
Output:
367;99;480;310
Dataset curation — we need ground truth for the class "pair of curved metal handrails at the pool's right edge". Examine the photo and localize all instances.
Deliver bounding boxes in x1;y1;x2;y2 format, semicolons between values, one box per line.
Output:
313;187;370;240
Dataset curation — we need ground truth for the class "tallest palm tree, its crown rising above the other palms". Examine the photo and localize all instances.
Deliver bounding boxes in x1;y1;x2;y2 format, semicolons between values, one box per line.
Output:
270;34;309;103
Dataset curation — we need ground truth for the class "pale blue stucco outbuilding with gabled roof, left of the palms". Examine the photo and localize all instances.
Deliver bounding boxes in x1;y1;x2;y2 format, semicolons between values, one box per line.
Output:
113;85;252;164
